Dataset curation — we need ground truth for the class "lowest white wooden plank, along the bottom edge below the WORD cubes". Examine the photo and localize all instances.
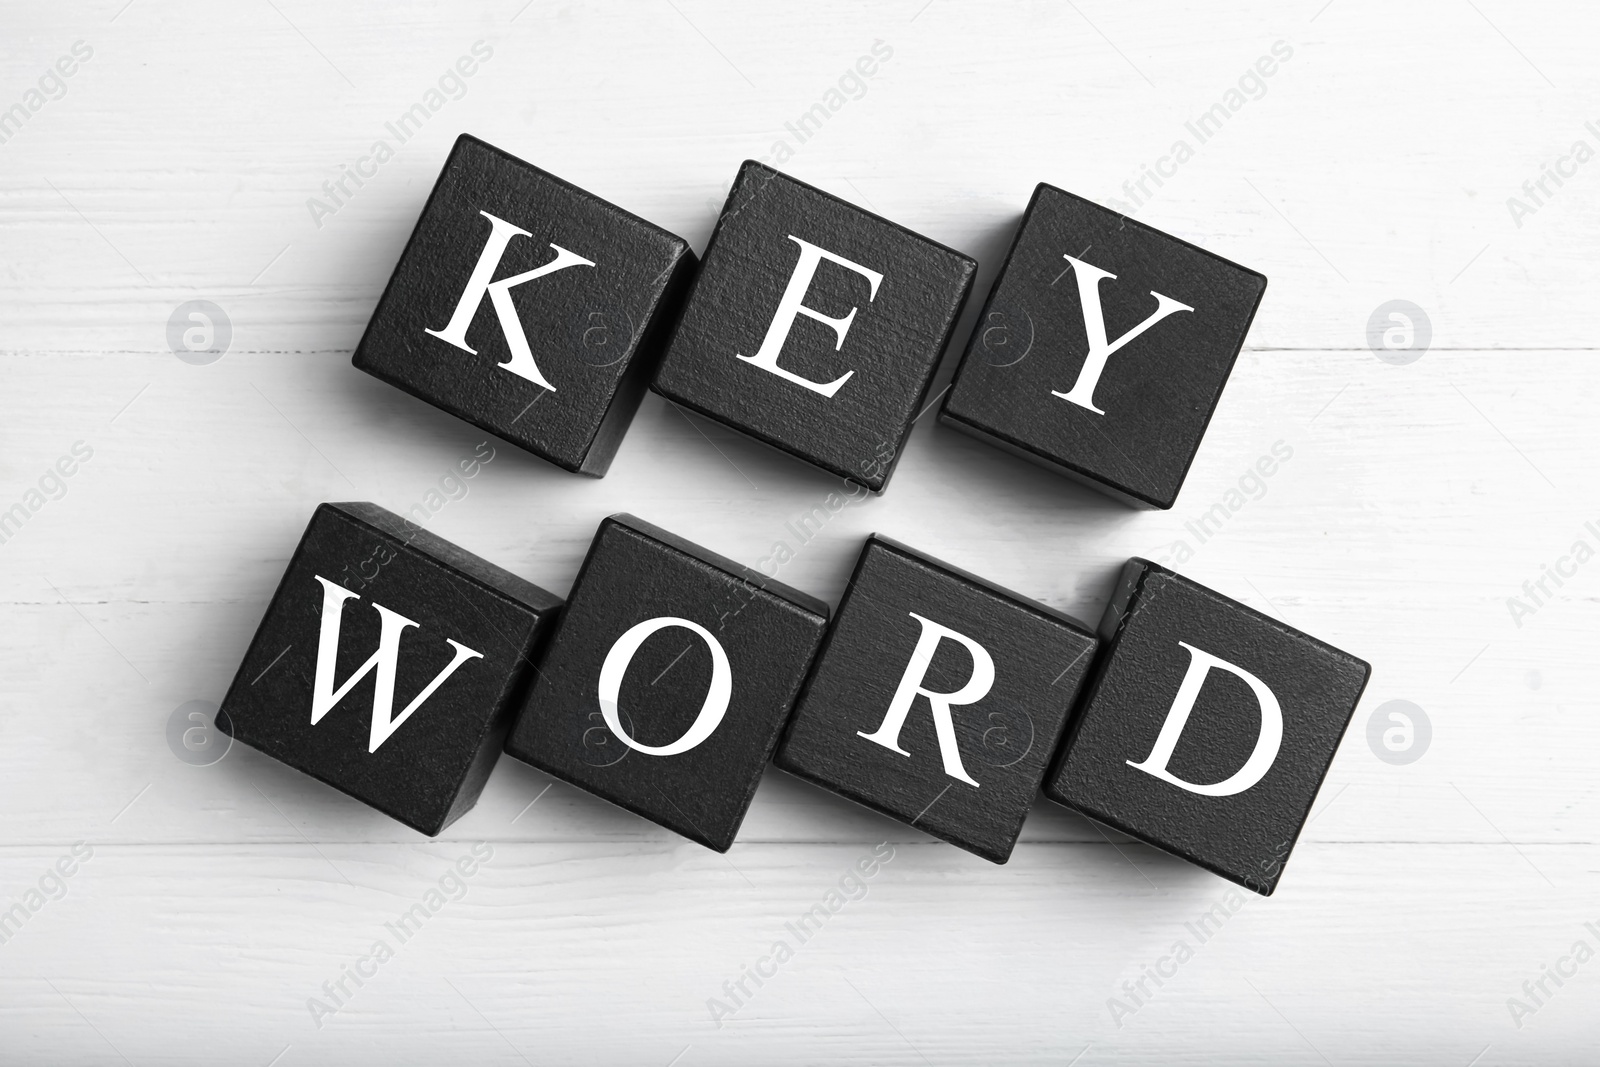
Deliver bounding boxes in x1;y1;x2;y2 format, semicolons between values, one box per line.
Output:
0;838;1600;1064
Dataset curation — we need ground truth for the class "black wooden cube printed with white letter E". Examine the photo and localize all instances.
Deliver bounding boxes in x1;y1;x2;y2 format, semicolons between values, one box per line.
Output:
653;162;978;493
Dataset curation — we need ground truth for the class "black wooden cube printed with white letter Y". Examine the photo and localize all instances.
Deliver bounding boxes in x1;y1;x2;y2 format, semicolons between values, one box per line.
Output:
939;184;1267;509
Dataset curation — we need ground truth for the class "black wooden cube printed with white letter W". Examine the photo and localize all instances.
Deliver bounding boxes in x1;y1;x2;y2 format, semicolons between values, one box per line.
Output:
216;504;562;835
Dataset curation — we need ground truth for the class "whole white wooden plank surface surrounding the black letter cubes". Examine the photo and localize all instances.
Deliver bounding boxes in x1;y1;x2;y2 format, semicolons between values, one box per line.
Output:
0;0;1600;1067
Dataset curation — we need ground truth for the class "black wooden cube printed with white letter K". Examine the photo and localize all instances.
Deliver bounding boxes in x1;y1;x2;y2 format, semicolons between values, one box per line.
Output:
354;134;694;475
